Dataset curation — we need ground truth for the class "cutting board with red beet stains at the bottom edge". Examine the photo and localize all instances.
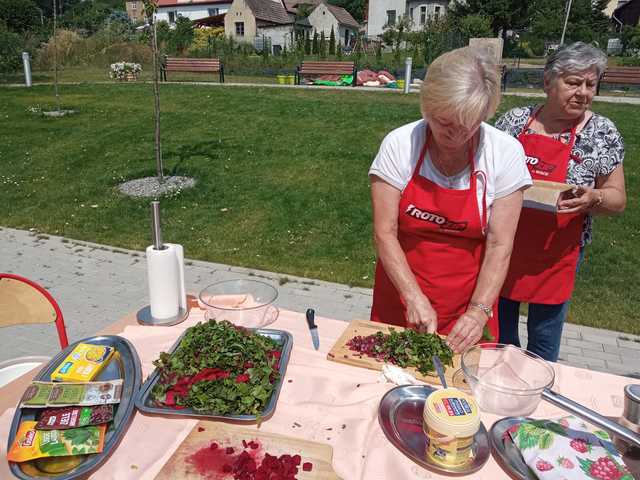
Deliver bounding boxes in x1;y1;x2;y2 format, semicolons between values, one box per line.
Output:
156;421;339;480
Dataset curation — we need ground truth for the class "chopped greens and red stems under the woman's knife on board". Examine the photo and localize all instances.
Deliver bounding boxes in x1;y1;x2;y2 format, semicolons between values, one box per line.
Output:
347;328;453;375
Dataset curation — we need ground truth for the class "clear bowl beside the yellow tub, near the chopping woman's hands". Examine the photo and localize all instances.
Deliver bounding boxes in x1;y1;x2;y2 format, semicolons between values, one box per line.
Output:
461;343;555;416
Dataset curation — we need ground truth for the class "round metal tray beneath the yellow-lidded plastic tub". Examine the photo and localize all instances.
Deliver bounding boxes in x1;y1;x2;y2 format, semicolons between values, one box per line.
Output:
378;385;491;475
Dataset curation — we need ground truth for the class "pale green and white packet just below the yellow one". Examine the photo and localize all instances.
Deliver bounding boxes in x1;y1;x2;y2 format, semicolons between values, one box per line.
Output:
20;378;122;408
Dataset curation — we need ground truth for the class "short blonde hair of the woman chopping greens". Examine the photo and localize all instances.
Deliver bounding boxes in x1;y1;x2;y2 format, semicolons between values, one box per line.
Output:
420;47;500;127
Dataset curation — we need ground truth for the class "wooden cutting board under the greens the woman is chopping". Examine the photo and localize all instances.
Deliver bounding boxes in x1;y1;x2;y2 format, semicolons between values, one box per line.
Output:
327;320;460;386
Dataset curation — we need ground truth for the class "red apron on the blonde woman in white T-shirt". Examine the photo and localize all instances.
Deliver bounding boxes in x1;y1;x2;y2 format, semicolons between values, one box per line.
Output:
371;127;498;338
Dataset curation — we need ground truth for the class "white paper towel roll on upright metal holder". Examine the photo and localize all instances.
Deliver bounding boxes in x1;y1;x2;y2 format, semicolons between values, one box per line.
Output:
147;245;180;319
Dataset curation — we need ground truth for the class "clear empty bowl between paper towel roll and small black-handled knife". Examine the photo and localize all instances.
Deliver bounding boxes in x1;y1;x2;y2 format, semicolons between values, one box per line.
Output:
198;279;279;328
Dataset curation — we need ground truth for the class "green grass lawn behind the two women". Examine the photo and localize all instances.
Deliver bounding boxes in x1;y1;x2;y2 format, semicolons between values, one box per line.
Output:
0;84;640;334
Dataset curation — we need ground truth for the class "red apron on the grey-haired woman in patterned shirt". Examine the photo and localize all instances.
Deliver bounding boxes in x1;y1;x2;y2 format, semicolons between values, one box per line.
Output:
501;110;584;305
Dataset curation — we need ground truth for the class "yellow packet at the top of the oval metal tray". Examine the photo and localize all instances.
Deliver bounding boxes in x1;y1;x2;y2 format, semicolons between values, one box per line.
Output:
51;343;115;382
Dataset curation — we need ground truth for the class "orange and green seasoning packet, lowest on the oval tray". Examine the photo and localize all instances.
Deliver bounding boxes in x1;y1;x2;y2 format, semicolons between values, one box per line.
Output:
7;421;107;462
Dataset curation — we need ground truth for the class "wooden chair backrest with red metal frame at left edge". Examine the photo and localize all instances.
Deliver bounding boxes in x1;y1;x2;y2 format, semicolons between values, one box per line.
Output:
0;273;69;349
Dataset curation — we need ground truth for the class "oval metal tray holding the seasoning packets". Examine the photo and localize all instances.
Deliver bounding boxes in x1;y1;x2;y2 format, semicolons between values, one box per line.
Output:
7;335;142;480
